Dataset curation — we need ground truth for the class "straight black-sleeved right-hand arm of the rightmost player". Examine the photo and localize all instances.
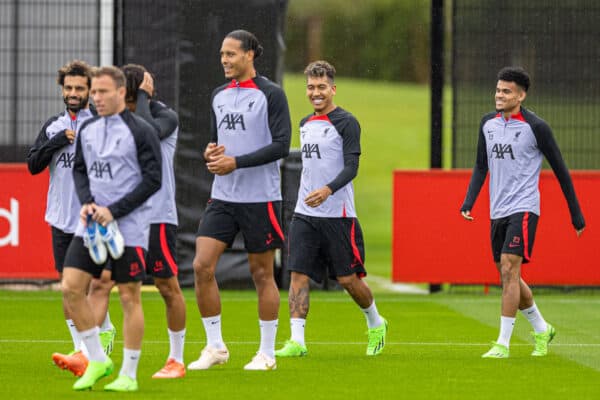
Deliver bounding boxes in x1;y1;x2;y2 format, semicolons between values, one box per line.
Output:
533;122;585;234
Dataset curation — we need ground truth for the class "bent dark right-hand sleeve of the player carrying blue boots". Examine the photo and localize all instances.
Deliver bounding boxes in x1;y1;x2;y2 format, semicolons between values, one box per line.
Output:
108;115;162;219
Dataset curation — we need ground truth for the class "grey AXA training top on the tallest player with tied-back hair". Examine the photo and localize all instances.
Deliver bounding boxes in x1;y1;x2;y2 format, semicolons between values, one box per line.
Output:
211;76;291;203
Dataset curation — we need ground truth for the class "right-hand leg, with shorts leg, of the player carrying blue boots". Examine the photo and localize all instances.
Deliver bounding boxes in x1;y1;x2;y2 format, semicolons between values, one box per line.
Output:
104;246;146;392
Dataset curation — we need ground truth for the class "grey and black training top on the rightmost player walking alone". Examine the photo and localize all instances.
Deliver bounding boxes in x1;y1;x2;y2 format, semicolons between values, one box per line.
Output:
461;107;585;229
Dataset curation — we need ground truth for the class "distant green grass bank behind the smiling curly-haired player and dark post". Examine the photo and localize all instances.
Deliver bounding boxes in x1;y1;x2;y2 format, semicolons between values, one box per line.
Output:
284;74;451;277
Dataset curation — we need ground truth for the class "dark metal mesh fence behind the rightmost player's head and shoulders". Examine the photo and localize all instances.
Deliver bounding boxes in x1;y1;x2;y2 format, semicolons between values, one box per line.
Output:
452;0;600;169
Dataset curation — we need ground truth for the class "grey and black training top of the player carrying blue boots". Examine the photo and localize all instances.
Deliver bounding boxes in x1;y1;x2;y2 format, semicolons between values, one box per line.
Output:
73;110;161;249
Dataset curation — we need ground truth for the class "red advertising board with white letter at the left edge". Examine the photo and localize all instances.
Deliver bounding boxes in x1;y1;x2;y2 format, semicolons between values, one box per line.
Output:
0;164;58;279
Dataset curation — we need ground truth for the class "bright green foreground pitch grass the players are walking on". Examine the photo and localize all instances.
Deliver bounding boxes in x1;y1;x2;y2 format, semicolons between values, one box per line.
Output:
0;290;600;400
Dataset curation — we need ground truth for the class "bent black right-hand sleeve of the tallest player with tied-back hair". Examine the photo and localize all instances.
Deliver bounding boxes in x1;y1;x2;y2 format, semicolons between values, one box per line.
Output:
235;89;292;168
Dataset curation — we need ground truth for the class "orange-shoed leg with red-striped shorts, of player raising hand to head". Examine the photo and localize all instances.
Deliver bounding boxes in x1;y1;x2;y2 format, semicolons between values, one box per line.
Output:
146;224;185;378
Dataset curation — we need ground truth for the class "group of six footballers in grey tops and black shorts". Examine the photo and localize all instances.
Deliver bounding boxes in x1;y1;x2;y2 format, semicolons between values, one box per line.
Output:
28;30;585;392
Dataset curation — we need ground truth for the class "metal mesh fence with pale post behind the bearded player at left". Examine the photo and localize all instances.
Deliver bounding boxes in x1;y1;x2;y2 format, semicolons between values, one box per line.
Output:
0;0;113;162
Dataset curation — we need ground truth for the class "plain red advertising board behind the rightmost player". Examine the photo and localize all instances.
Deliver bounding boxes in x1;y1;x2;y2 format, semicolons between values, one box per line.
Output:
392;170;600;285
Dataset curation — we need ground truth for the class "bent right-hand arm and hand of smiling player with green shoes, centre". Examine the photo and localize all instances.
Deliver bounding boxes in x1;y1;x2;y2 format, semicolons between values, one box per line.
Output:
304;118;360;207
